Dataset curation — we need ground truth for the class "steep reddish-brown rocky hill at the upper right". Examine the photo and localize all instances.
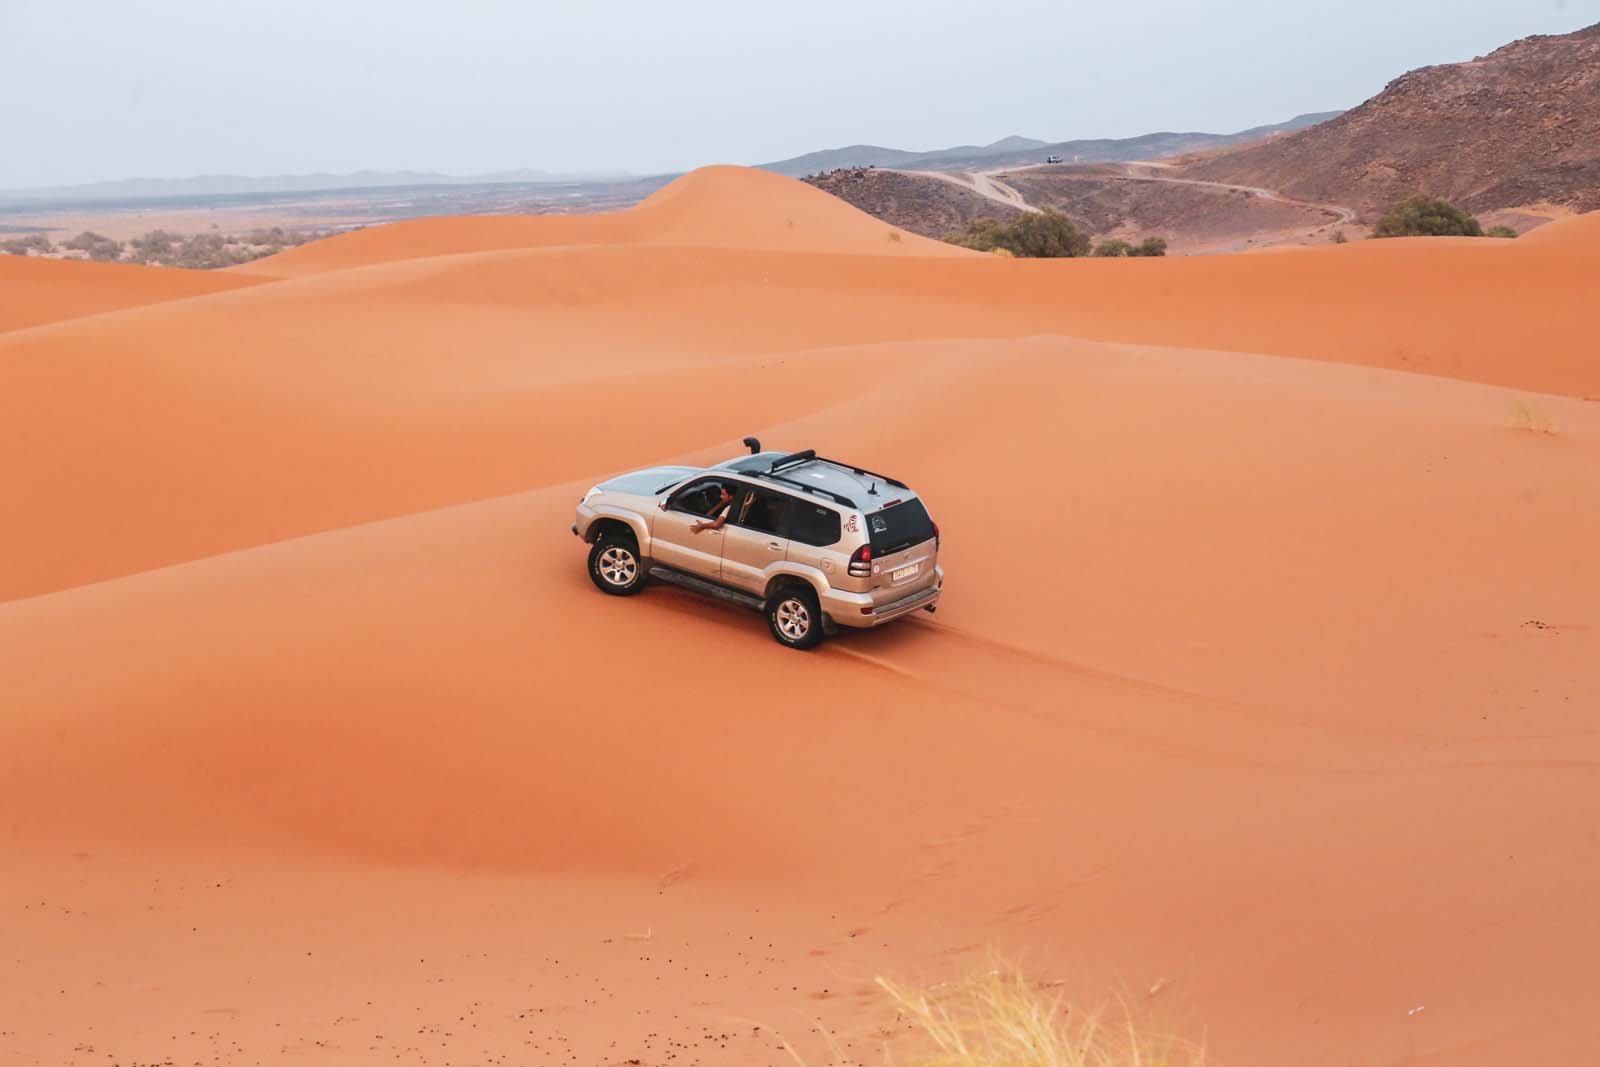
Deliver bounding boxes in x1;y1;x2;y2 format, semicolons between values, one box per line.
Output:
1184;26;1600;218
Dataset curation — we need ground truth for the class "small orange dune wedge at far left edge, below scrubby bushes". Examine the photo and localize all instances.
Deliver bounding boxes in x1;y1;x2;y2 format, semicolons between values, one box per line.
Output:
0;256;259;333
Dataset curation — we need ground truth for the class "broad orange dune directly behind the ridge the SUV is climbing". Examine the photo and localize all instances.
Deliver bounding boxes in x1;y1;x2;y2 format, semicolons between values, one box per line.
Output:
0;215;1600;597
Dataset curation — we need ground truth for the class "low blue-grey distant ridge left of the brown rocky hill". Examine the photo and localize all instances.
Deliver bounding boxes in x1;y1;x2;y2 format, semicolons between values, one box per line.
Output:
762;110;1341;178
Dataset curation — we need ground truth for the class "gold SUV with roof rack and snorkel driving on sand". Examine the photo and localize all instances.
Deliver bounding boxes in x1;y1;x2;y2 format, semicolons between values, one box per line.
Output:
573;437;944;648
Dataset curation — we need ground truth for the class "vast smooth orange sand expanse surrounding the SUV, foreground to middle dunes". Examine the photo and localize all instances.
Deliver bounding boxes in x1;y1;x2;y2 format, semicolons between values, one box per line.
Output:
0;171;1600;1067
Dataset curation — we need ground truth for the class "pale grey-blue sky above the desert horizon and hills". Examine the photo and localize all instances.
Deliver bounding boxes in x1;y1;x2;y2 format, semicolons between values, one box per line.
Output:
0;0;1600;189
